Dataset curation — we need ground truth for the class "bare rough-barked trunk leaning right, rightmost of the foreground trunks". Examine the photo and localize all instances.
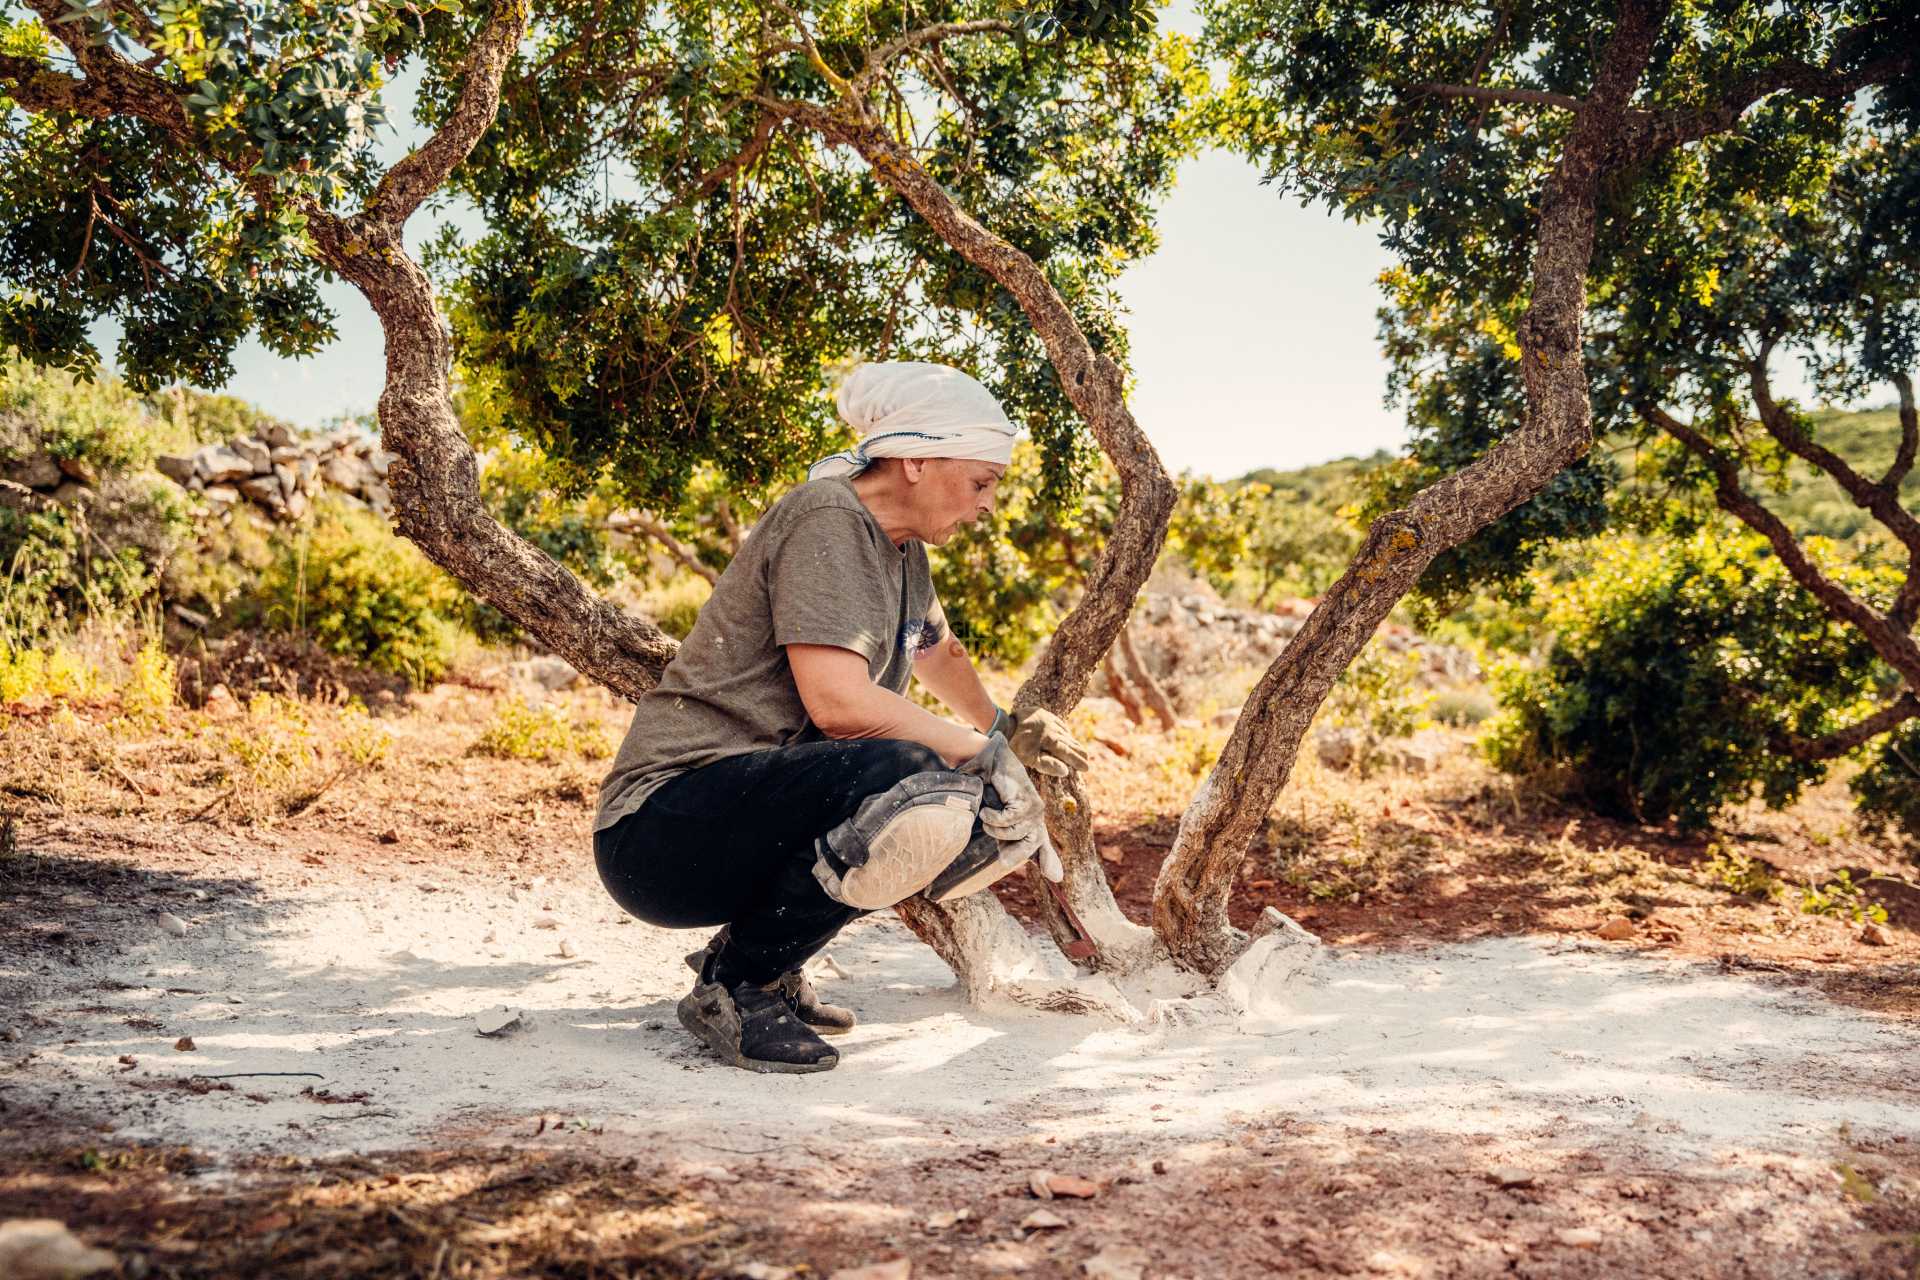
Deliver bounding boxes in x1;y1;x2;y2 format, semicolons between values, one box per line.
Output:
1154;0;1665;973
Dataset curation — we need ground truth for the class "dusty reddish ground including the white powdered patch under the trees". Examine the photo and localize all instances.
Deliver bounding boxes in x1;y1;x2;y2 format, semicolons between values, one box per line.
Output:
0;685;1920;1278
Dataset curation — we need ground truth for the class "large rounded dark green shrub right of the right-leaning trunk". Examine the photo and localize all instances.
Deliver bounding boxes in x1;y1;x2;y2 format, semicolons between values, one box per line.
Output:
1482;528;1891;827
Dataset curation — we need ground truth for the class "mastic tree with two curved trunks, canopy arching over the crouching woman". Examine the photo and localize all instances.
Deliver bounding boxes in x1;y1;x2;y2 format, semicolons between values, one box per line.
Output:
0;0;1202;986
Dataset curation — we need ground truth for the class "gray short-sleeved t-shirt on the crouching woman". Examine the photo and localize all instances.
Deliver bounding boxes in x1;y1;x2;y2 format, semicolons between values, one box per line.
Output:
593;478;945;831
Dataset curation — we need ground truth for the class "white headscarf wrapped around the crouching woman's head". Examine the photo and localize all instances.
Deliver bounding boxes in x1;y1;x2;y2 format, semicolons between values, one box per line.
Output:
806;361;1020;480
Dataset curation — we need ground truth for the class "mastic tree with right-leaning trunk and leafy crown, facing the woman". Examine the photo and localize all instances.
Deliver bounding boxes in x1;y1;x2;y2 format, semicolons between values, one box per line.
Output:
1154;0;1916;969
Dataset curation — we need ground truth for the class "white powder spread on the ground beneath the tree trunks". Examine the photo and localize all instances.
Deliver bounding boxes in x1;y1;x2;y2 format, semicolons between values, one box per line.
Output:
0;873;1920;1159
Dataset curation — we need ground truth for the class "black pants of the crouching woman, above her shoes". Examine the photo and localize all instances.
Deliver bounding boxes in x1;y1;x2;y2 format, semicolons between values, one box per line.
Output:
593;739;947;983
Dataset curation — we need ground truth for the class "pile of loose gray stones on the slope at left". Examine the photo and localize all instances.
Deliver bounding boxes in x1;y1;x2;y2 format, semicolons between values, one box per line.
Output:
154;422;394;520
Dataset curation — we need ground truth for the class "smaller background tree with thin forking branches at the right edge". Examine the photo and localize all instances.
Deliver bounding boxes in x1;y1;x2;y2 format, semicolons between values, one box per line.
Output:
1384;67;1920;821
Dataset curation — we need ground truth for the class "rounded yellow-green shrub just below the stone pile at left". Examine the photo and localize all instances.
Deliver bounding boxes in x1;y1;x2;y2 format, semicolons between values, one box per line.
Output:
257;503;463;685
